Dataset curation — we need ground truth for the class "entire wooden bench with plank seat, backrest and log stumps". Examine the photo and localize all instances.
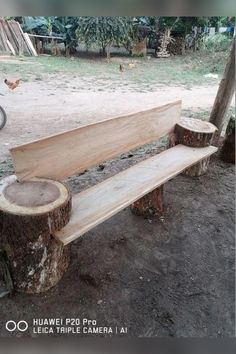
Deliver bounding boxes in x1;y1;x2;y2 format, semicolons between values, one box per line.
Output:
0;101;217;292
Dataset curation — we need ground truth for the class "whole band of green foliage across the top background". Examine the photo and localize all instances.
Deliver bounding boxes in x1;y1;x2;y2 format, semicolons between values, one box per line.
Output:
5;16;235;54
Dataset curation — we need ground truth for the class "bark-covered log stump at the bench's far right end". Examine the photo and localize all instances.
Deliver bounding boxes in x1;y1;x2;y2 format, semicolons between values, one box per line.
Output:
175;117;217;177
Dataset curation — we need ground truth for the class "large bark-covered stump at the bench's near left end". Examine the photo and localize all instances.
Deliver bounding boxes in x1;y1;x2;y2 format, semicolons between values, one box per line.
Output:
0;176;71;293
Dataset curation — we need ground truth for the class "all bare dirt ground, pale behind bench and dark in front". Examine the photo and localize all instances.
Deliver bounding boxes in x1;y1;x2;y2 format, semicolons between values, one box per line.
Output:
0;55;235;337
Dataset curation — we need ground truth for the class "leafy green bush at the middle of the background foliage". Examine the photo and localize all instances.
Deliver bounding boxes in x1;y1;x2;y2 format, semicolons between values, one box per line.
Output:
77;16;134;53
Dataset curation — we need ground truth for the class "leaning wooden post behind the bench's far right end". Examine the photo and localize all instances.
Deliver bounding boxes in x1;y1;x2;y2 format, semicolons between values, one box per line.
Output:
210;38;235;143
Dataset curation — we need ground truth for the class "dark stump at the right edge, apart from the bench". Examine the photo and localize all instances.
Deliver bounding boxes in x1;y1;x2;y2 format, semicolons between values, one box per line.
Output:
220;117;235;164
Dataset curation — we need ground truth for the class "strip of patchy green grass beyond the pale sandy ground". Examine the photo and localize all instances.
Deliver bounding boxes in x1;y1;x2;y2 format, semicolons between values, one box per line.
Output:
0;51;228;92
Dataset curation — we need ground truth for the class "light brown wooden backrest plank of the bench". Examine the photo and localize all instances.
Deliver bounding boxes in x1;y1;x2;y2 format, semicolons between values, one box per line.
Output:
10;101;181;180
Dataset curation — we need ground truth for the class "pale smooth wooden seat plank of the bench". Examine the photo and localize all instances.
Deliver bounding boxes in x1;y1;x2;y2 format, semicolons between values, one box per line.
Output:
54;145;217;244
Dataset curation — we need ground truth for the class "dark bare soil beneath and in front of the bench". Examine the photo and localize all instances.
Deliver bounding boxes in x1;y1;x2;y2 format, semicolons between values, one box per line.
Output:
0;148;235;337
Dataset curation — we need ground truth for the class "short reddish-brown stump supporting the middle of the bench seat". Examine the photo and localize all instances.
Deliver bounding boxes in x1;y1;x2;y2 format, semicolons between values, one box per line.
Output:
130;186;164;218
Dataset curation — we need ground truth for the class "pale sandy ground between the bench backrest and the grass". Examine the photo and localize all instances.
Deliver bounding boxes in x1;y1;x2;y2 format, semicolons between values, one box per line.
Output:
0;79;234;162
